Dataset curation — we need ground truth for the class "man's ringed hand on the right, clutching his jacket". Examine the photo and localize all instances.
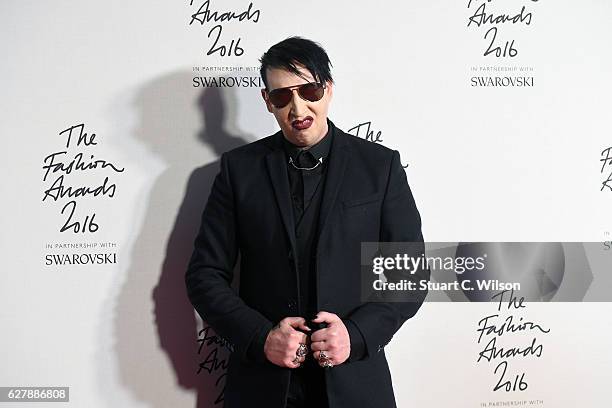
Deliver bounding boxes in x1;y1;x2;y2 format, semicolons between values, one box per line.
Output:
310;312;351;366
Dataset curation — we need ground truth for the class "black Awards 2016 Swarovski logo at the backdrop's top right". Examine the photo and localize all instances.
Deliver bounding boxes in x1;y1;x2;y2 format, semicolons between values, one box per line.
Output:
467;0;539;87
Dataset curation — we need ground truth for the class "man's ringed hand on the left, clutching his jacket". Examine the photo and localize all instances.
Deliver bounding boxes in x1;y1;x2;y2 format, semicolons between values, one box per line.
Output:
264;317;310;368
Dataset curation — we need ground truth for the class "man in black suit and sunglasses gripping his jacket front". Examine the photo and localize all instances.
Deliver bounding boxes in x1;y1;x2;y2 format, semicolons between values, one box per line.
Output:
186;37;427;408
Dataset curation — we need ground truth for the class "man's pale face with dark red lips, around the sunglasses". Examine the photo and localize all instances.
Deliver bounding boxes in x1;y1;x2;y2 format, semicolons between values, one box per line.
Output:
261;65;333;147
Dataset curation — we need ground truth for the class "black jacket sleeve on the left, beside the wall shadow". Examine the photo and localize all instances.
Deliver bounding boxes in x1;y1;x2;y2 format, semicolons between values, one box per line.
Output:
185;154;273;361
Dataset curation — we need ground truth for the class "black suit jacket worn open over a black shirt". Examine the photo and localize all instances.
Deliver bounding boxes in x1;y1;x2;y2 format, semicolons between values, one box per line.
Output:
185;122;428;408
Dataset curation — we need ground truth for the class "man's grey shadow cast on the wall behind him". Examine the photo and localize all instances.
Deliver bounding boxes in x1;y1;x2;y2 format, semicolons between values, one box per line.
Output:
113;72;250;408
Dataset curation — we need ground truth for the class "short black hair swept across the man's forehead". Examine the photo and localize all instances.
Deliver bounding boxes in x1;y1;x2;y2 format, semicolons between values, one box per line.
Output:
259;37;334;88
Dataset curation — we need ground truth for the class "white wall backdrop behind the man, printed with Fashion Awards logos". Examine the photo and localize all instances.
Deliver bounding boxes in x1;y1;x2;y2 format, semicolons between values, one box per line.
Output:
0;0;612;408
